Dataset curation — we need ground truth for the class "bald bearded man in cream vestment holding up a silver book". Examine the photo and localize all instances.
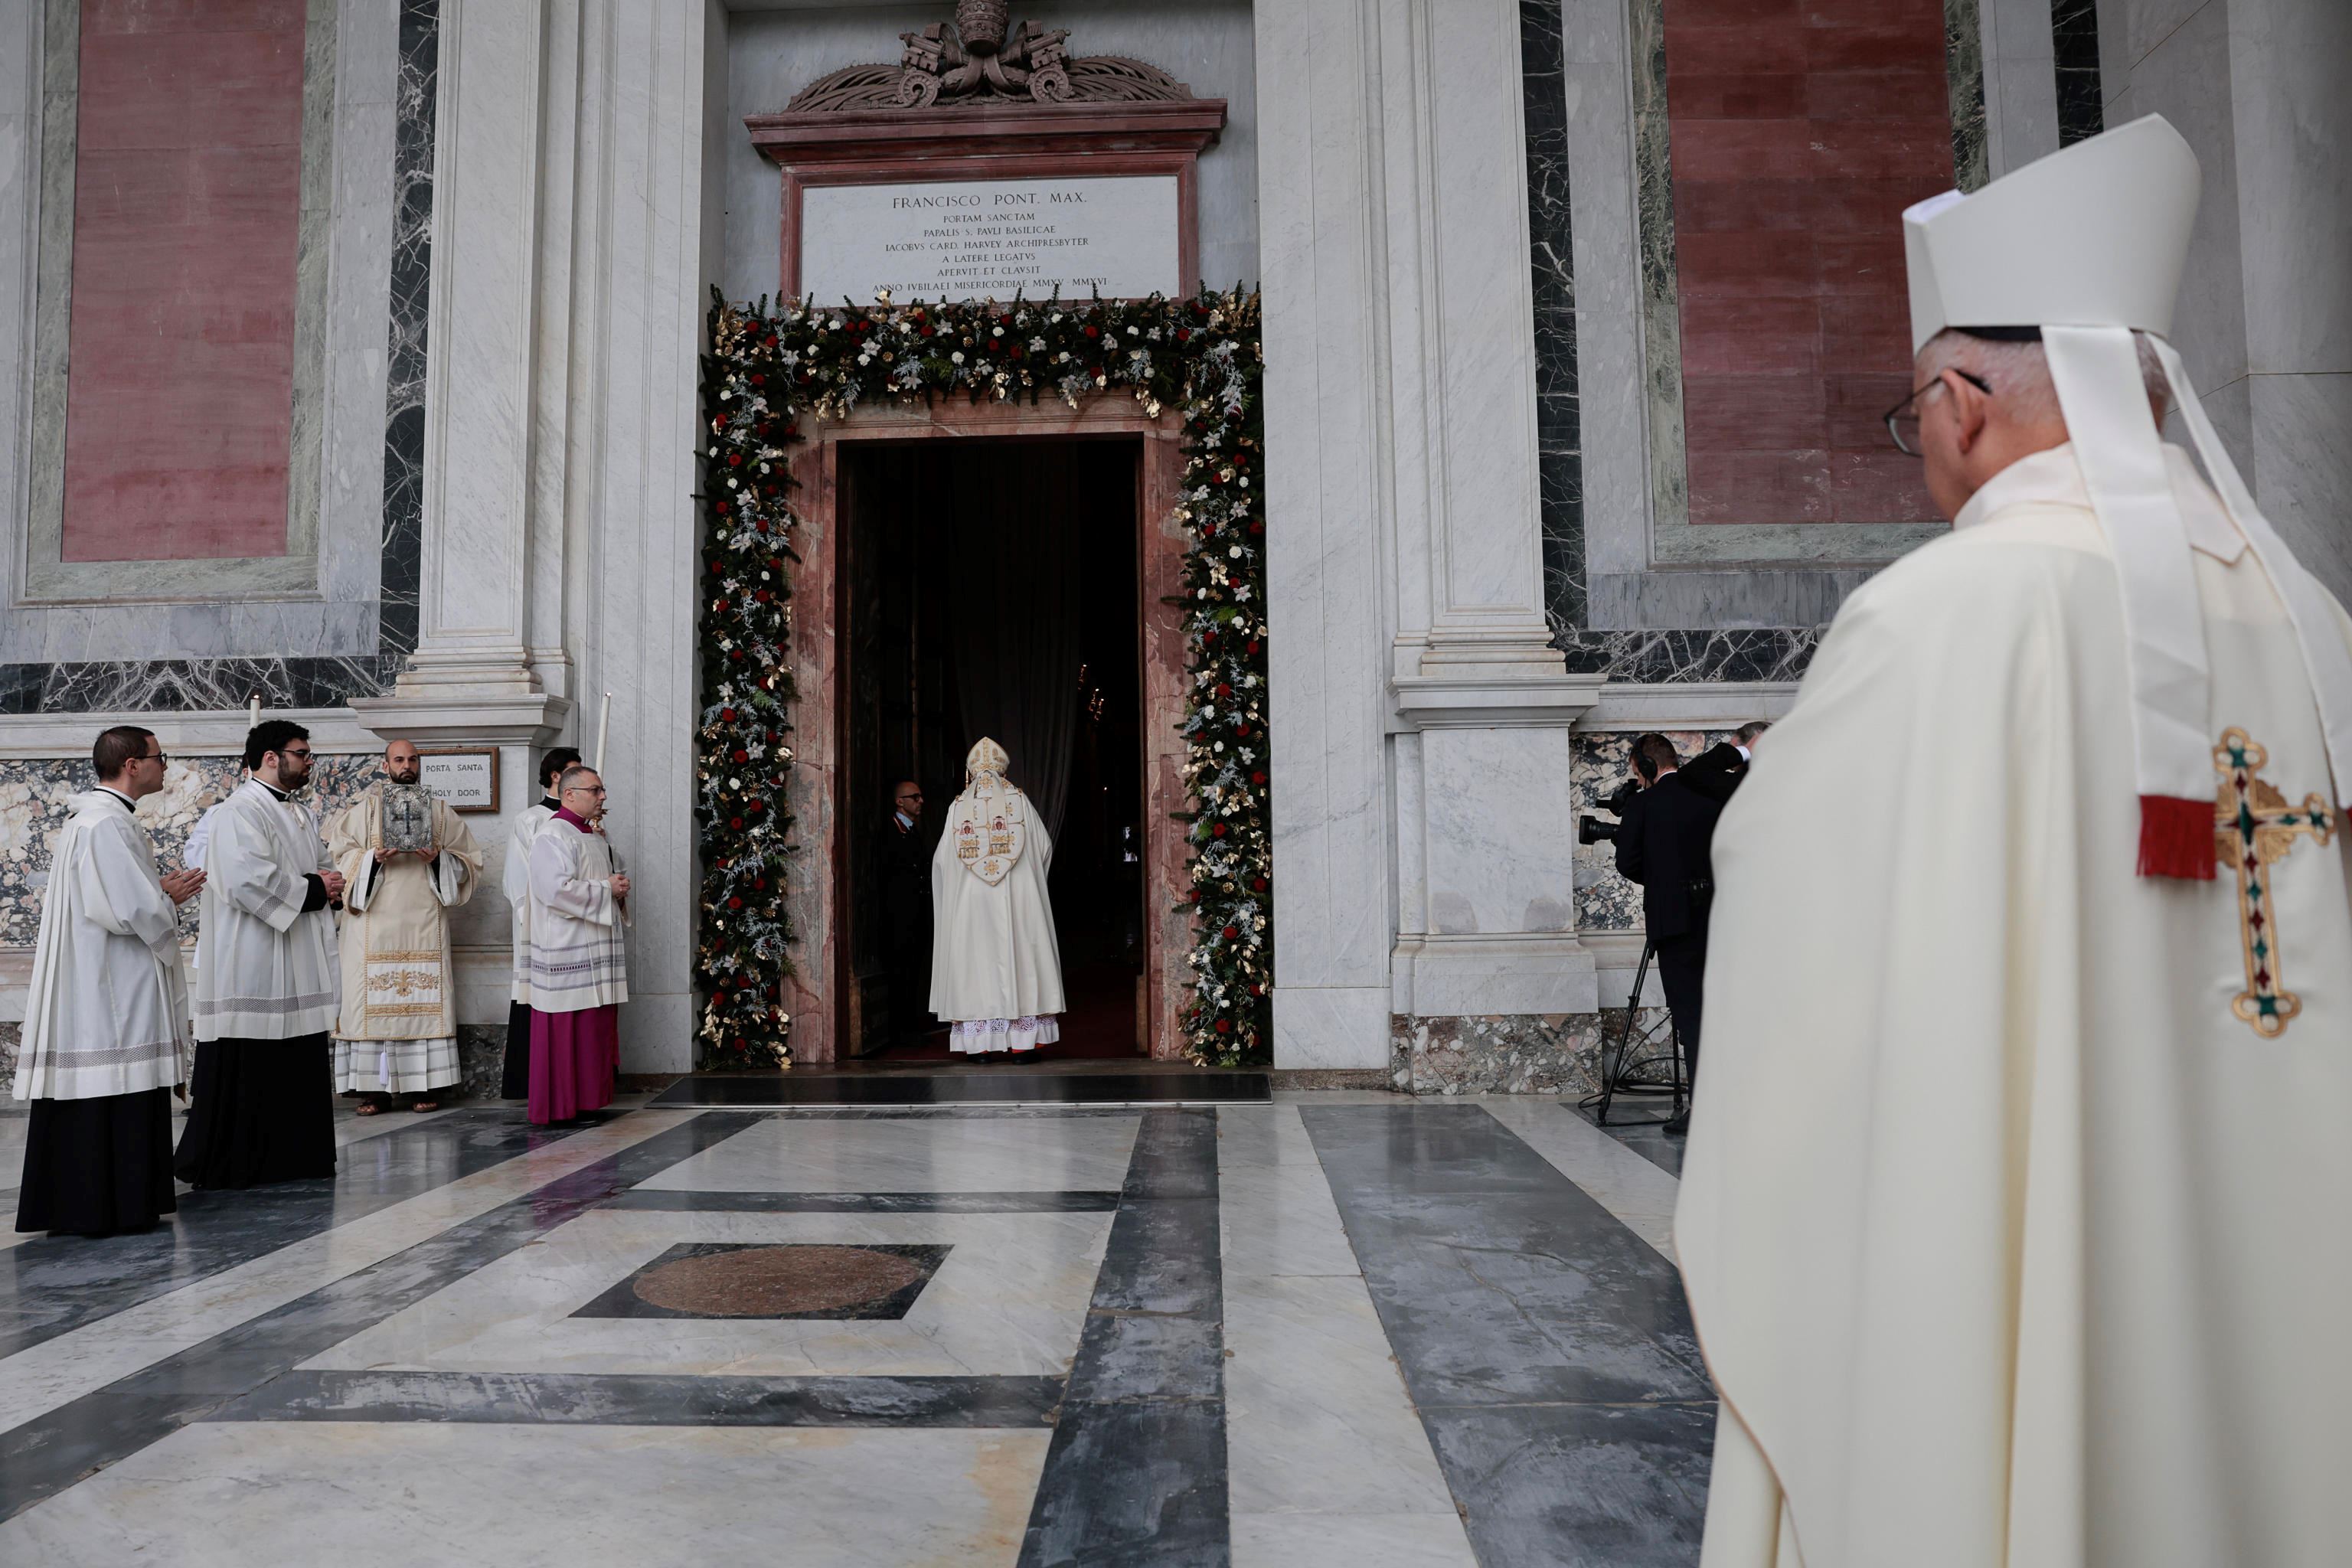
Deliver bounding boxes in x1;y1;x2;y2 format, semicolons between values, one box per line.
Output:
327;740;482;1114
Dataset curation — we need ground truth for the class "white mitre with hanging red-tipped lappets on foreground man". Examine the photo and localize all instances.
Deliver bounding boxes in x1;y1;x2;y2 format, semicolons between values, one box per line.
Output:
1903;115;2352;879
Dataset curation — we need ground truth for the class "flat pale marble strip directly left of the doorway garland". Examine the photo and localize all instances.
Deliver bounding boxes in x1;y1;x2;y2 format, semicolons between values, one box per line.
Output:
567;0;714;1072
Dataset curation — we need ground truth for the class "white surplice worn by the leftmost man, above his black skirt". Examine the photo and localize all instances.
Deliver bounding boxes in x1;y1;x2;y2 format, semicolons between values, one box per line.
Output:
17;790;195;1100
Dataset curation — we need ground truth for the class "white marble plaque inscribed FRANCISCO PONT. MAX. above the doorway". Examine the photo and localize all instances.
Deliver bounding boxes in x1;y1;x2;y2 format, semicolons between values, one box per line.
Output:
799;174;1185;303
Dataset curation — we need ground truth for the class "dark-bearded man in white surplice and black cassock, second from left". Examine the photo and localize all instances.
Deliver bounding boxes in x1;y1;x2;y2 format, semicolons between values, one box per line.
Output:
174;720;344;1187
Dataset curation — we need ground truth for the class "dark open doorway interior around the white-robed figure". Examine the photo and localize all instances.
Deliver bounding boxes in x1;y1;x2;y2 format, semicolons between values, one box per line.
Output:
835;437;1148;1060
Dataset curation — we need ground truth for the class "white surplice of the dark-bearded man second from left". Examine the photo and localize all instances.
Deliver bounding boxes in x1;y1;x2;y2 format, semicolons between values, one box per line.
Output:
191;778;336;1039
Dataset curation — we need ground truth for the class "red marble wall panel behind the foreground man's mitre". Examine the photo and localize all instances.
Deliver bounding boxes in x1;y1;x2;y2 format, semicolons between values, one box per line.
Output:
1665;0;1952;524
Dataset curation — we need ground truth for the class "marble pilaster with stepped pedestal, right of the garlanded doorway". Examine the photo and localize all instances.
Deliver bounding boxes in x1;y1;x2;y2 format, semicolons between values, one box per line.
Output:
1378;0;1599;1037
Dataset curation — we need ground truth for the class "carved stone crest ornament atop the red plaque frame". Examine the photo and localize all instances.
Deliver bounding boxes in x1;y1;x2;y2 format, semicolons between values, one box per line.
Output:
788;0;1193;113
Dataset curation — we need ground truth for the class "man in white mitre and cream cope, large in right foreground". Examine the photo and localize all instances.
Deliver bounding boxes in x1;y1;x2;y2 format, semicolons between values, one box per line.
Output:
1674;118;2352;1568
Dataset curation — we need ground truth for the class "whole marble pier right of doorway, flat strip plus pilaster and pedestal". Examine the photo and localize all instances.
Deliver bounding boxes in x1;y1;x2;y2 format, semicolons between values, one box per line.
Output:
1256;0;1599;1067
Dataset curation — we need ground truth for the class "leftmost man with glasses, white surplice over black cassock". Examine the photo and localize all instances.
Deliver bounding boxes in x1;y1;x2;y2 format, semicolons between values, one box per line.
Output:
17;724;204;1236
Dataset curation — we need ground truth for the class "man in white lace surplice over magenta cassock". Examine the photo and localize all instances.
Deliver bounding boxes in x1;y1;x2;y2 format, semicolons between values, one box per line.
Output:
524;764;628;1126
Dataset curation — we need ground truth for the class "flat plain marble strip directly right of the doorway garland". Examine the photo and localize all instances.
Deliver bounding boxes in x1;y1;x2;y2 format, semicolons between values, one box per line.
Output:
1251;0;1393;1067
